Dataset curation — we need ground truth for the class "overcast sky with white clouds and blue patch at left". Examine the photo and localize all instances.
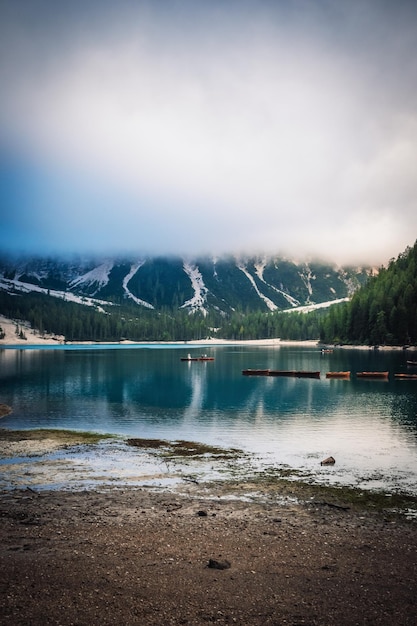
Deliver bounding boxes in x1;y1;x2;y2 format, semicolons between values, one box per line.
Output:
0;0;417;264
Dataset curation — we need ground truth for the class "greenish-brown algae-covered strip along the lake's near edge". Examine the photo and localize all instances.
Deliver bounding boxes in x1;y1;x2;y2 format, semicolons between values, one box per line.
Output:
0;429;417;518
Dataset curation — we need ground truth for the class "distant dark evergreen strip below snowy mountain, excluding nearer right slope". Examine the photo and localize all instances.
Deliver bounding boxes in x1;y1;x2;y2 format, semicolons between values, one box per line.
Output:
0;292;322;341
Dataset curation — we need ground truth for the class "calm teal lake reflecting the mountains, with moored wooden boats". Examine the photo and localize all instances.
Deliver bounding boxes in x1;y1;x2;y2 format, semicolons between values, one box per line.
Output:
0;344;417;495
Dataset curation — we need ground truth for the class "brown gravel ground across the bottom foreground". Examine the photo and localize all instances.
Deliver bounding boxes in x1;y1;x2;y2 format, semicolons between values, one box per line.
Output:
0;485;417;626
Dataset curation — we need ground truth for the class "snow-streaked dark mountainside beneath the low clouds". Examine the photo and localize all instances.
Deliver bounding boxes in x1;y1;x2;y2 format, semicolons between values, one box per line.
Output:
0;256;372;314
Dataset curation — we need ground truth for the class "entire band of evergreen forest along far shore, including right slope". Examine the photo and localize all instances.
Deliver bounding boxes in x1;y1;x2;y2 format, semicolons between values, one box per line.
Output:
0;242;417;345
